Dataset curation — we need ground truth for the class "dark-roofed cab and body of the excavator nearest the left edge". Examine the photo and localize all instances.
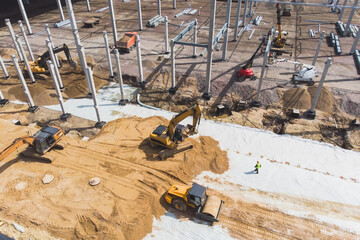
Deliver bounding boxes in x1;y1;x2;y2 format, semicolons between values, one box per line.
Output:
33;126;59;154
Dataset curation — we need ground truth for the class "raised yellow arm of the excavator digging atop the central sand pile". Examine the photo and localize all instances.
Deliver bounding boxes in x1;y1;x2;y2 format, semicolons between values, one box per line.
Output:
167;104;201;139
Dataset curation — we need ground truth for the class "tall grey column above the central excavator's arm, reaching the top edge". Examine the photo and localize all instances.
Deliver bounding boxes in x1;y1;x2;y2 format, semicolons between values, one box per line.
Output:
202;0;216;100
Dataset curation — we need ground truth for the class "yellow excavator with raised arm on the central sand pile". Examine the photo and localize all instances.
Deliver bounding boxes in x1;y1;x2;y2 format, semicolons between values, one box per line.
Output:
150;104;201;160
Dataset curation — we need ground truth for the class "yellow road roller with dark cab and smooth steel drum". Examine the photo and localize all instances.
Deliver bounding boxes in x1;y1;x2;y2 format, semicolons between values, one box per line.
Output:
165;183;224;222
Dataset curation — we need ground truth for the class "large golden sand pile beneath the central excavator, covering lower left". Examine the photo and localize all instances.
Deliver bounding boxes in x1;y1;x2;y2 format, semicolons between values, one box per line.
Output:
0;117;228;240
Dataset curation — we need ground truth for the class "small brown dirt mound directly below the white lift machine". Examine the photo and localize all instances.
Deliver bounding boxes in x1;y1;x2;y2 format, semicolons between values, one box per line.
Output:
282;88;311;109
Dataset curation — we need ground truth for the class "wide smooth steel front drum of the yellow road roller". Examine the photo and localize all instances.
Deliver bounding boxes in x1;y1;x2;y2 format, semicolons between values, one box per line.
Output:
196;196;224;222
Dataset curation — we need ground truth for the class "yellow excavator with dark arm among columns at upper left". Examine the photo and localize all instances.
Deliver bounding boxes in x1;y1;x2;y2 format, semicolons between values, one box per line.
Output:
25;43;76;74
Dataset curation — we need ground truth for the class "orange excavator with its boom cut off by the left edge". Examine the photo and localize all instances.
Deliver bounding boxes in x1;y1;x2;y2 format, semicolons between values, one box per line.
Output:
0;126;64;162
